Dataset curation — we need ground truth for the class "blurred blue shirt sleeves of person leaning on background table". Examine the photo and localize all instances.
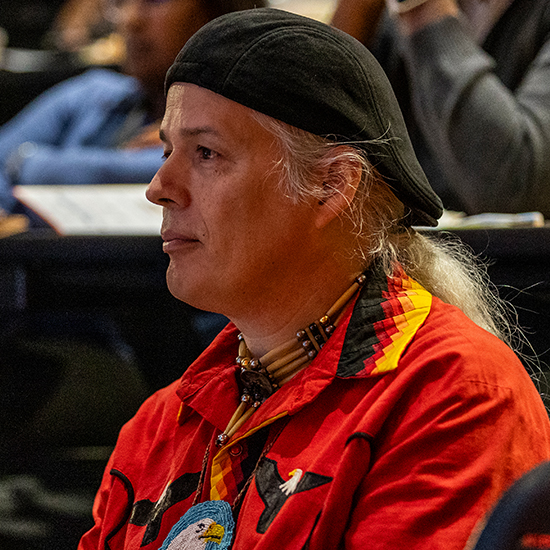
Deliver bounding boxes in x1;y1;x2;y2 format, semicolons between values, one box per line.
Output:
0;70;162;211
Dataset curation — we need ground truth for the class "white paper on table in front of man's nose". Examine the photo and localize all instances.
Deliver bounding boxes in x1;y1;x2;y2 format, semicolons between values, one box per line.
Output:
13;183;162;235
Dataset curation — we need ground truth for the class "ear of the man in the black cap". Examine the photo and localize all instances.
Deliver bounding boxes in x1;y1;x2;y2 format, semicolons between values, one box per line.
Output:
315;146;363;229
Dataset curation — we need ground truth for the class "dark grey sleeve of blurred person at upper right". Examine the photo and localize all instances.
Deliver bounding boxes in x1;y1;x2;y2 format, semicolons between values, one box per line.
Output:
402;17;550;216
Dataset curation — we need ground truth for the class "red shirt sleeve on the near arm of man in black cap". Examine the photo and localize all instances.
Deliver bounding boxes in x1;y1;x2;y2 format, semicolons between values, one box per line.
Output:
345;338;549;550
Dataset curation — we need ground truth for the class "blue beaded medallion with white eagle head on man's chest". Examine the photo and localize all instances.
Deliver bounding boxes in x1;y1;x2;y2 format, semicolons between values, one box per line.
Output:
160;500;235;550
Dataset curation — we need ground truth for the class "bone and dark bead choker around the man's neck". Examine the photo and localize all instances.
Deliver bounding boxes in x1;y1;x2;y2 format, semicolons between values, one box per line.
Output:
216;275;366;447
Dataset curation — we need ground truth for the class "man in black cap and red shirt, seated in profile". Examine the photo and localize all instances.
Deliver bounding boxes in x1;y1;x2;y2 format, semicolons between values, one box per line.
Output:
80;9;550;550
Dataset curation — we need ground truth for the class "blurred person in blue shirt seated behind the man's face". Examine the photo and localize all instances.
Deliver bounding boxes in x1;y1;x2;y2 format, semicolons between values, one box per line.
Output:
0;0;264;216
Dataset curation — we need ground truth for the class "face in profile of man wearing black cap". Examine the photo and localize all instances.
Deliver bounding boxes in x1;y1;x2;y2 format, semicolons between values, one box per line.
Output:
147;84;319;318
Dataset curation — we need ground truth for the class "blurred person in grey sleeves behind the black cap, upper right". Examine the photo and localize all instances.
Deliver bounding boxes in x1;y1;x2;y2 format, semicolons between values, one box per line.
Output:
333;0;550;217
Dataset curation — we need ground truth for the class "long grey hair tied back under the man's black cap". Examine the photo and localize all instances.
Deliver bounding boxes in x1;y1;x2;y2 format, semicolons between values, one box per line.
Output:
254;113;520;345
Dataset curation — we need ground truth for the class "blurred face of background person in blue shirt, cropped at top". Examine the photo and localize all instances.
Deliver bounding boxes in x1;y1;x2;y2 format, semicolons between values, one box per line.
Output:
113;0;208;87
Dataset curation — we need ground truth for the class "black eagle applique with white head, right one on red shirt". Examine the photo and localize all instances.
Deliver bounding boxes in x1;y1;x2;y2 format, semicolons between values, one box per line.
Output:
255;458;332;533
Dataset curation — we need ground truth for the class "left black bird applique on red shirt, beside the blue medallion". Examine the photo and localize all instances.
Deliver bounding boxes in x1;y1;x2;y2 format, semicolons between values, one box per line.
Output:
130;472;200;546
